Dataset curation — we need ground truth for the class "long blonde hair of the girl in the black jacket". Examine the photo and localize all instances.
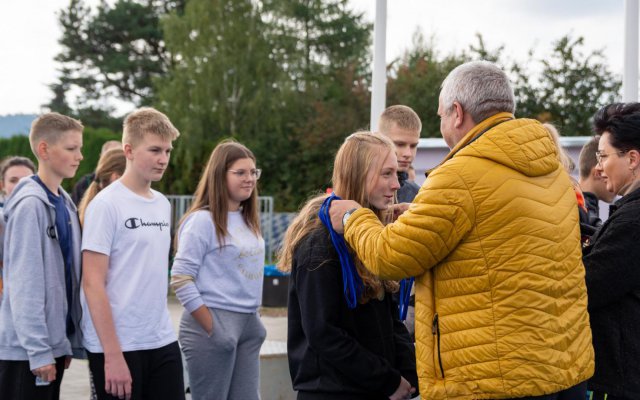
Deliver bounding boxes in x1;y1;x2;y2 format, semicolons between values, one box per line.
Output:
278;132;399;303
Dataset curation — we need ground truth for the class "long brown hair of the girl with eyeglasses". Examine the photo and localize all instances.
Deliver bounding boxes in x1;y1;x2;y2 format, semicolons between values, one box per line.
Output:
175;139;260;249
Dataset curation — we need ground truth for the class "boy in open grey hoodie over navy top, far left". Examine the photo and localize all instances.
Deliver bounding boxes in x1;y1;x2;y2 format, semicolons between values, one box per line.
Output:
0;113;83;400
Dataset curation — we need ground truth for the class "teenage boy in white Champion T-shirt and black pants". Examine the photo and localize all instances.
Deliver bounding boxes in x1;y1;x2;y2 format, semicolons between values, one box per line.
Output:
82;108;184;400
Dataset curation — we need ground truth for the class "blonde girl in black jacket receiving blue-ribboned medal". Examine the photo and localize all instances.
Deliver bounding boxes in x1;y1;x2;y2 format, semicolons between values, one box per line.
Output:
279;133;417;400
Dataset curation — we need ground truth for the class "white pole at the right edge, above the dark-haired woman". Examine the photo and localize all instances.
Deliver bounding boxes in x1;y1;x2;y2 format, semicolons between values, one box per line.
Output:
622;0;638;102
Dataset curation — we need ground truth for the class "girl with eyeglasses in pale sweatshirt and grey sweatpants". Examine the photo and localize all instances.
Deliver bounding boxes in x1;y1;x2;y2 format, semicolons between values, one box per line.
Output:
171;141;266;400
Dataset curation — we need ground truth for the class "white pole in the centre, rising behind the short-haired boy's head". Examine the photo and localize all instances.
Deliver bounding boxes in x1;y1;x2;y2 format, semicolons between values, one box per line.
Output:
370;0;387;131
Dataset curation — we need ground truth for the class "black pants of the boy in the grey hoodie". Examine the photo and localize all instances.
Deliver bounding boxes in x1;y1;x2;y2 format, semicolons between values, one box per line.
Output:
0;357;65;400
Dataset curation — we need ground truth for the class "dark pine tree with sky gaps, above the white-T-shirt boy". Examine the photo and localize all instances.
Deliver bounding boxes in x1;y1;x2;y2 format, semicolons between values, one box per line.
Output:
47;0;185;127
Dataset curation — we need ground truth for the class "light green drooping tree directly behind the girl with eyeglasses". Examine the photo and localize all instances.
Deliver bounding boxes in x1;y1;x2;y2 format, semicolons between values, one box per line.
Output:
157;0;281;193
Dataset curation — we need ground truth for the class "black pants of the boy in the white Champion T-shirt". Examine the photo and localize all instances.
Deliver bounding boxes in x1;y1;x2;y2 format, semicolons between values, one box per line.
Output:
87;342;184;400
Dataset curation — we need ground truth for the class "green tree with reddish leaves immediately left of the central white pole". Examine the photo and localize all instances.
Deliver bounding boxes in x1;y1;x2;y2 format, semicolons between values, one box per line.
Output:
262;0;372;209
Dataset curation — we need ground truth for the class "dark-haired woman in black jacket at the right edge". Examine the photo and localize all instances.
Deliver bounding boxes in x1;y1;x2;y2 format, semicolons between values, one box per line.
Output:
583;103;640;400
